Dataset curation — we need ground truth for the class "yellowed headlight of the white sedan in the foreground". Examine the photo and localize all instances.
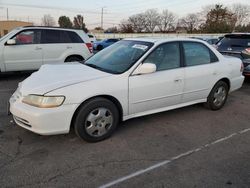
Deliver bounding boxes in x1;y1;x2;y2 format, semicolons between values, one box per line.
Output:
22;95;65;108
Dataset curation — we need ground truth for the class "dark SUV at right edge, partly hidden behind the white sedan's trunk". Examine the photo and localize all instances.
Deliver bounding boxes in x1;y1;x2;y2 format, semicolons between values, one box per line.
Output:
217;33;250;76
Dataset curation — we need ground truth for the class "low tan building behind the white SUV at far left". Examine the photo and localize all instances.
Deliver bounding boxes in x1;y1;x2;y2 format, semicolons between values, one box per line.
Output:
0;20;33;37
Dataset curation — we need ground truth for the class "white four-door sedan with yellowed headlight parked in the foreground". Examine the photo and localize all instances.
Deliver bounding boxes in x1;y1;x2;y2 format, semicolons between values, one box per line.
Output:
10;38;244;142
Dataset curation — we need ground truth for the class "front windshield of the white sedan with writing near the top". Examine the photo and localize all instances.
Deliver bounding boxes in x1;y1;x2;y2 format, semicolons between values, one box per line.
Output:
85;40;153;74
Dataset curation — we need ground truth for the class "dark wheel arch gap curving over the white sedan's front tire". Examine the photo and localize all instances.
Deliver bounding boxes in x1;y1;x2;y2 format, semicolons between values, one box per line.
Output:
70;95;123;128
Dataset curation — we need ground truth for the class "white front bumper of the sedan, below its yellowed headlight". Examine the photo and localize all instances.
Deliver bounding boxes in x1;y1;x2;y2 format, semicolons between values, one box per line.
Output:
10;99;77;135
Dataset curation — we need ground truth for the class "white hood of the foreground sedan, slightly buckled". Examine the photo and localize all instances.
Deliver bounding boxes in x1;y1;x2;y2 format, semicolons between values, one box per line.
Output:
19;63;111;96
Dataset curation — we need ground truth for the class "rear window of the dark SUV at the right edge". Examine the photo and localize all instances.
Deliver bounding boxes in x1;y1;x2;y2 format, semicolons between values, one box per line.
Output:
218;35;250;48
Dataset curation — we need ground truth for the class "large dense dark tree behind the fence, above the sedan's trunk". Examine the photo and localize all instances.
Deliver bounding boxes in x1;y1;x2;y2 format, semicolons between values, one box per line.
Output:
203;5;237;33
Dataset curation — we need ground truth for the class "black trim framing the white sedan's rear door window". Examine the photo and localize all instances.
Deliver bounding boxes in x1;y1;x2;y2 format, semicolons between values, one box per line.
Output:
181;41;219;67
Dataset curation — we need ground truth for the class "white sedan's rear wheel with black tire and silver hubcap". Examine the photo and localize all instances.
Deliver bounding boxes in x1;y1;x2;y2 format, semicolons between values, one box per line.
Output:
205;81;229;110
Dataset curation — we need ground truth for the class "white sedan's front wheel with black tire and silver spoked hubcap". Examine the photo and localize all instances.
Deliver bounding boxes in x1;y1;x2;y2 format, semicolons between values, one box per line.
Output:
74;98;119;142
